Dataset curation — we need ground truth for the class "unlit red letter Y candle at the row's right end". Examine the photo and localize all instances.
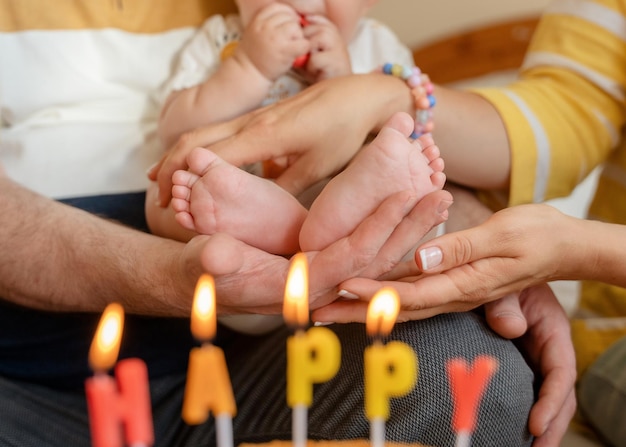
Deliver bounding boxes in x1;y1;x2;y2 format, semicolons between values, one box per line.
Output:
446;355;498;447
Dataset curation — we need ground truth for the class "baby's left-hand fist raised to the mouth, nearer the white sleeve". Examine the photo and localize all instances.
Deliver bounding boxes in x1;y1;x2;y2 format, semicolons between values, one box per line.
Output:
235;3;310;81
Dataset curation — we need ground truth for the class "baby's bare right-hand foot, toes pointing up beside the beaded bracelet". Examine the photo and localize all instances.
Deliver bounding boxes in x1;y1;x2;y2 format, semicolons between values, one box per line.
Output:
300;113;445;251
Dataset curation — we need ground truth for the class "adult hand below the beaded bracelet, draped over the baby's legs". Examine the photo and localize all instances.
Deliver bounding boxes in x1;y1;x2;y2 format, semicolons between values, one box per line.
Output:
148;73;413;206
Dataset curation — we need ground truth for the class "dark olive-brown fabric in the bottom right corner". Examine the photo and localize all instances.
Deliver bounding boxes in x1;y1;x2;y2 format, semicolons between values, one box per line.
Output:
578;337;626;447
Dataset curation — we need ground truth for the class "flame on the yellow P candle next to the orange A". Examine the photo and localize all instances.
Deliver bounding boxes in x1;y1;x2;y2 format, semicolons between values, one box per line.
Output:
283;253;309;327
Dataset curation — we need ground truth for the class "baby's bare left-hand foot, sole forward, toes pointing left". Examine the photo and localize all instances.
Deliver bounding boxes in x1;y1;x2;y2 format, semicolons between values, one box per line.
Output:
172;148;307;254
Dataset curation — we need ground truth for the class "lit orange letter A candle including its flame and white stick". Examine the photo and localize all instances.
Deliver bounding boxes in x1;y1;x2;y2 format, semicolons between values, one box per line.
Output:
182;274;237;447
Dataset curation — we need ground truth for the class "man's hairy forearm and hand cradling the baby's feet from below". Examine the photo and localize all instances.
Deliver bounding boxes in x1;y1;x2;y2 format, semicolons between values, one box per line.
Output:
0;175;442;316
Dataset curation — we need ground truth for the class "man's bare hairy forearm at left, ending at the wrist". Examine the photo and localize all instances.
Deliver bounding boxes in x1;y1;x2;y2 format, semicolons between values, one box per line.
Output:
0;176;196;316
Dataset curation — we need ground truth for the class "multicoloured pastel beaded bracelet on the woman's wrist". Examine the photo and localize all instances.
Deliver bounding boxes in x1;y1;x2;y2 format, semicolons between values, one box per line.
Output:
382;63;436;138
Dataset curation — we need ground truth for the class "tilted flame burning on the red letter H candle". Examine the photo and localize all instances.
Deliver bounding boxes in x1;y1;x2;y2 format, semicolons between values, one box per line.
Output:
89;303;124;371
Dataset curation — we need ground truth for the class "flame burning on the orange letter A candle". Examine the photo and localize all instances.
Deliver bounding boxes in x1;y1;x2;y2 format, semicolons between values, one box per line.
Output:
191;274;217;341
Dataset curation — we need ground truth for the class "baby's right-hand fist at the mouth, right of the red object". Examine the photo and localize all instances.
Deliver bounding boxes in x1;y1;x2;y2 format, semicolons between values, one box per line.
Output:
303;16;352;82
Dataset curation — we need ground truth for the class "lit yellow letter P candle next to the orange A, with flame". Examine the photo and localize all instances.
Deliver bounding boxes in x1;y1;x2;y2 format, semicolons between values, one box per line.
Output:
283;253;341;447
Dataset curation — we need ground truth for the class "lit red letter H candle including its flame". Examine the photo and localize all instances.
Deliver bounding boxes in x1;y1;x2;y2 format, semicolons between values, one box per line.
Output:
85;303;154;447
